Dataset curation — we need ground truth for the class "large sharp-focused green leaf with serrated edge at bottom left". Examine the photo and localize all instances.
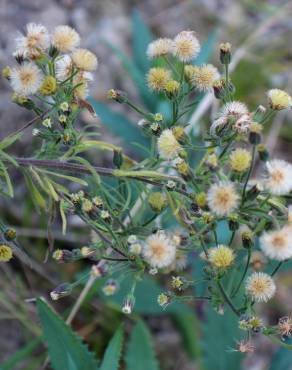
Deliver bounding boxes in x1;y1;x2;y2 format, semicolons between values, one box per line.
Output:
37;299;98;370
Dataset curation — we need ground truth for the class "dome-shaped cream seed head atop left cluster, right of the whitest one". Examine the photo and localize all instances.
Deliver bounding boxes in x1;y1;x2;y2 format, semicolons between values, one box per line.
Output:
52;25;80;53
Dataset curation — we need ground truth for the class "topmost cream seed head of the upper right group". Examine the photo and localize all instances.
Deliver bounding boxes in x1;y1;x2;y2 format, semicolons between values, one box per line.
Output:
172;31;200;63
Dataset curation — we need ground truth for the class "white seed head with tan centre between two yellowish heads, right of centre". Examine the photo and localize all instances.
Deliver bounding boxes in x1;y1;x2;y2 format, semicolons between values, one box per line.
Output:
207;181;239;217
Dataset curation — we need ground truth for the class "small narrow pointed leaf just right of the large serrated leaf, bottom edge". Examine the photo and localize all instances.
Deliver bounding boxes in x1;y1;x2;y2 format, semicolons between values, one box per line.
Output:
99;326;124;370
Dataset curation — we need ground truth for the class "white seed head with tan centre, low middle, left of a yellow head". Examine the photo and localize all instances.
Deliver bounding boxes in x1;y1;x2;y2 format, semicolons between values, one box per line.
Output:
143;231;176;268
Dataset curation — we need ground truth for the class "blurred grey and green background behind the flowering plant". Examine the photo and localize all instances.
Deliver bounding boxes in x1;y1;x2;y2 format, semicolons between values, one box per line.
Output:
0;0;292;370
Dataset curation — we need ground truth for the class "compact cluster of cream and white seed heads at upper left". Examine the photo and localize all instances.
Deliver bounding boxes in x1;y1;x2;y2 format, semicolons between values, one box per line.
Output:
3;23;98;99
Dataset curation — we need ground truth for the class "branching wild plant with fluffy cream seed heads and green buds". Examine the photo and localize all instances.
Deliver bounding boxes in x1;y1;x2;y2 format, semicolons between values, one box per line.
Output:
0;24;292;352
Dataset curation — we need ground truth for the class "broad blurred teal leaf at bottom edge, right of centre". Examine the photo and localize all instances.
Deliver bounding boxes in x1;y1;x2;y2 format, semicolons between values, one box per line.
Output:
202;305;243;370
